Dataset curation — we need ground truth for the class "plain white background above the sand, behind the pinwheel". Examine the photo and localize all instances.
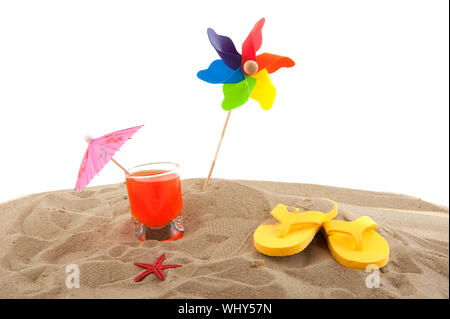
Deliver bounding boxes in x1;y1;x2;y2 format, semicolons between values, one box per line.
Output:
0;0;449;205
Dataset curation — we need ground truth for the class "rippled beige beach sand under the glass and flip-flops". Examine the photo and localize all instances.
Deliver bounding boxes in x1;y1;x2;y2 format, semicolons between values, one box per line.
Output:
0;179;449;298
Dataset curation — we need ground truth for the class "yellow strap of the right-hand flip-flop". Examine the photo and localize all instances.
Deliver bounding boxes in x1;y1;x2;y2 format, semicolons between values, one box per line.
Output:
324;216;378;250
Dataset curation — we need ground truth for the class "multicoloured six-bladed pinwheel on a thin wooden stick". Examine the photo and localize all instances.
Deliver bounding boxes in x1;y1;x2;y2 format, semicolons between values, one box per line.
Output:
197;18;295;190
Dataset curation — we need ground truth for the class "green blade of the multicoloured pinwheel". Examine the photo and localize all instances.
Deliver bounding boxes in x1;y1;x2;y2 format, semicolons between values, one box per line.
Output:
222;76;256;111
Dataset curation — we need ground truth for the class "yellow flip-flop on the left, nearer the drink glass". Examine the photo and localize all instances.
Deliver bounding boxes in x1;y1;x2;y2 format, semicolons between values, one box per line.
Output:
253;200;337;256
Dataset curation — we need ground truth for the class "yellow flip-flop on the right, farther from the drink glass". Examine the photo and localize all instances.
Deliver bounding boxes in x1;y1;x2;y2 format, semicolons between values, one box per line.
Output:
323;216;389;269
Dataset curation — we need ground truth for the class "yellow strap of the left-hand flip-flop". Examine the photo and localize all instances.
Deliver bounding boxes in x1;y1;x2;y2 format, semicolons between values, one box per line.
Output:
271;204;324;237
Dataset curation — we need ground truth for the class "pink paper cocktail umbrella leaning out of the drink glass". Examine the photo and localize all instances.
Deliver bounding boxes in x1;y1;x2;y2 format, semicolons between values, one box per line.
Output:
75;125;143;191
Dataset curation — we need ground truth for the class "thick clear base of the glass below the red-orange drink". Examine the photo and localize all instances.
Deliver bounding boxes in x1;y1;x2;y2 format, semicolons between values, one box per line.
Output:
131;214;184;241
